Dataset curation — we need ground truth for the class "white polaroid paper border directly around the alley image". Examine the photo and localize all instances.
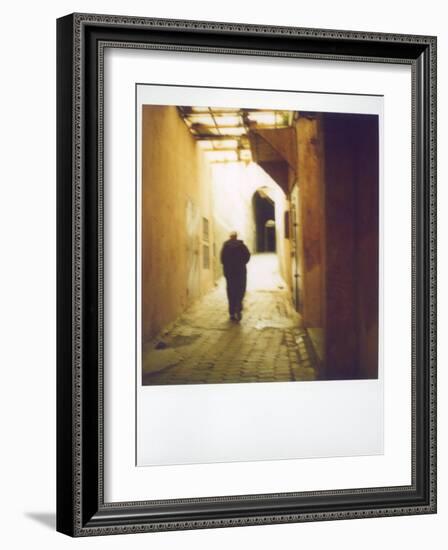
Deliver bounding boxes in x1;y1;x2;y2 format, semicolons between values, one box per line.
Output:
134;84;383;466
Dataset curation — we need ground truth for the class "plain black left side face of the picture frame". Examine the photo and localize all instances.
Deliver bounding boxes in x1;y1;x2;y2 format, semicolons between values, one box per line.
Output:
56;16;74;535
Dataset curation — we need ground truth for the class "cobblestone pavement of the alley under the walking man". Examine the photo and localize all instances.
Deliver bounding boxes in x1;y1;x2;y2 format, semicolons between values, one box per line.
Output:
142;254;317;385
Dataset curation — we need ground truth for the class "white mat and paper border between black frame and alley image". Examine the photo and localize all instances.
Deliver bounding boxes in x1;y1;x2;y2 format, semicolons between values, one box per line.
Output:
104;49;411;501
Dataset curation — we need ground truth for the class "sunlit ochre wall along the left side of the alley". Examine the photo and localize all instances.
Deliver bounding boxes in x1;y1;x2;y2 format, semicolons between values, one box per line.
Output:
141;105;214;343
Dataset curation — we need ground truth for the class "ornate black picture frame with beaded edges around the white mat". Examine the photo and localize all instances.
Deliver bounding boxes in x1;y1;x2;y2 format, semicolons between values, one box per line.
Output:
57;14;436;536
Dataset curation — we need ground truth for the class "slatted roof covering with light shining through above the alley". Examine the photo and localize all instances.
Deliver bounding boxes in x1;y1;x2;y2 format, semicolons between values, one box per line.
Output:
178;107;294;162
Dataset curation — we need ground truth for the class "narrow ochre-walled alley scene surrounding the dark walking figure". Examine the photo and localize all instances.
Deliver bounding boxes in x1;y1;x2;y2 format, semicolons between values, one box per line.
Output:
142;104;379;385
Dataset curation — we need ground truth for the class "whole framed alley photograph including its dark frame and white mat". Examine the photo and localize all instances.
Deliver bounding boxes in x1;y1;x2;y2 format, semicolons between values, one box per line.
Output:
57;14;436;536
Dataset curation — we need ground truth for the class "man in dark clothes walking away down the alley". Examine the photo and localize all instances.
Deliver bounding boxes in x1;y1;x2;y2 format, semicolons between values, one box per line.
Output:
221;231;250;321
